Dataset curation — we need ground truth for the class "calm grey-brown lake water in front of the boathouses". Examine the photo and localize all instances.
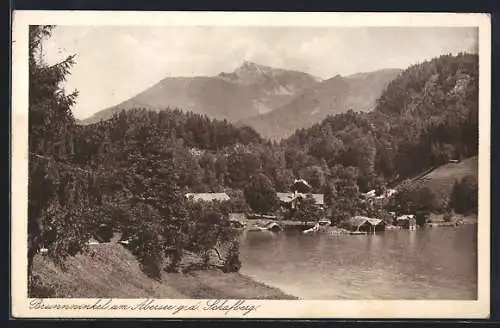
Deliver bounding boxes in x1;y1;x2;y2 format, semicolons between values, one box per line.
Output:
241;224;477;300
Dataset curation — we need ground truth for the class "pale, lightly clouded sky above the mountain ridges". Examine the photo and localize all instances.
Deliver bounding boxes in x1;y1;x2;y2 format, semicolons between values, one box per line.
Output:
43;26;477;119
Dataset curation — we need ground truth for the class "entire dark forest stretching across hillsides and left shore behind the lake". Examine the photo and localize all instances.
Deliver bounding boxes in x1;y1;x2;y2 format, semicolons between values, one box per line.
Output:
29;26;478;294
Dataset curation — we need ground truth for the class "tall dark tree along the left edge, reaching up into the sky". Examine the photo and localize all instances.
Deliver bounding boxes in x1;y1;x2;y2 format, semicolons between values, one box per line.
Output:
28;25;102;281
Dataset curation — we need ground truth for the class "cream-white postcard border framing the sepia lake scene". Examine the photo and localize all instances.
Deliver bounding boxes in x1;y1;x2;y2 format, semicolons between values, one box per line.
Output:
11;11;491;319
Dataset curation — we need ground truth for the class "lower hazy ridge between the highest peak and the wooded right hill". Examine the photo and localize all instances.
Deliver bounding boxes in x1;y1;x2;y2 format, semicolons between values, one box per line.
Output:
239;69;401;139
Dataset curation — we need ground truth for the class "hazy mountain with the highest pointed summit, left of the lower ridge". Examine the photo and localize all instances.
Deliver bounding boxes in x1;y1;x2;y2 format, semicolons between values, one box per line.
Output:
78;61;320;124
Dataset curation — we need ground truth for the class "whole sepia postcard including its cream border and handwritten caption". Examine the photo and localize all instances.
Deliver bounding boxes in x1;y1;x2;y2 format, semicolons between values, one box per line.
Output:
11;12;490;317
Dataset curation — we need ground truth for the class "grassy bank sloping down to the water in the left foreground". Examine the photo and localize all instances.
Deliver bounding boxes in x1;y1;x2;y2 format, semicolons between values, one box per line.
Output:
29;243;296;299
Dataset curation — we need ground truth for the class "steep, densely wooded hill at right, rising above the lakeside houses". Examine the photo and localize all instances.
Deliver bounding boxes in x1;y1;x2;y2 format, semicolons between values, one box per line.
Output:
283;54;478;189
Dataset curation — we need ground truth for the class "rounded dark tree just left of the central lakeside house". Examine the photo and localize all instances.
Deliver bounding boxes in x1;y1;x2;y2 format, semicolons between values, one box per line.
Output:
244;173;279;214
